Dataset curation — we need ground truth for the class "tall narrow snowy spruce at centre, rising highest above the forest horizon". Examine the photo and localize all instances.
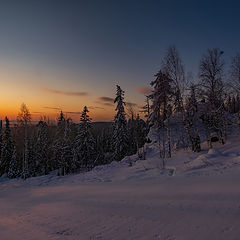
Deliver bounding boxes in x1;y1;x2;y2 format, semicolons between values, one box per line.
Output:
113;85;128;161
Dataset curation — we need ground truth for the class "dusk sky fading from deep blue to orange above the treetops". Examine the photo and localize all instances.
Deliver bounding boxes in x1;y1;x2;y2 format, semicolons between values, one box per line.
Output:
0;0;240;121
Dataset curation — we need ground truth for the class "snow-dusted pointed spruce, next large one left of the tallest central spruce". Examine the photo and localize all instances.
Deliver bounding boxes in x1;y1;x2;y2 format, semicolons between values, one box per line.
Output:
75;106;96;169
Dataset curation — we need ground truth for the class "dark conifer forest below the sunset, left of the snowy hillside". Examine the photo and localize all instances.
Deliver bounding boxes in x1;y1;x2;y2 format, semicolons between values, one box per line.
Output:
0;86;148;179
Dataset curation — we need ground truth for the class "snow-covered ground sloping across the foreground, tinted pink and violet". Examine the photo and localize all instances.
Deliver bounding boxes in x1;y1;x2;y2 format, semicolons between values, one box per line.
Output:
0;134;240;240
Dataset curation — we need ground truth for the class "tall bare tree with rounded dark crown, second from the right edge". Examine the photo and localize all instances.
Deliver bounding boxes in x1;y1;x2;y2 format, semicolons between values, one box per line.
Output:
199;48;226;146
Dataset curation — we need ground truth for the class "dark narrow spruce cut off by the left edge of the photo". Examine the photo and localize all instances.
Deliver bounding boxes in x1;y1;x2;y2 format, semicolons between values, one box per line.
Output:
0;117;14;176
